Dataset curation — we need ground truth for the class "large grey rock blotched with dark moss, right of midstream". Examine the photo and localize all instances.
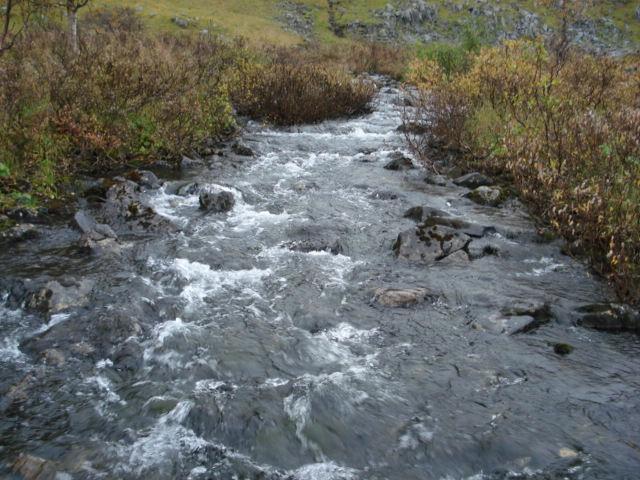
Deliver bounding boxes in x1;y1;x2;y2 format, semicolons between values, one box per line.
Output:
393;225;471;263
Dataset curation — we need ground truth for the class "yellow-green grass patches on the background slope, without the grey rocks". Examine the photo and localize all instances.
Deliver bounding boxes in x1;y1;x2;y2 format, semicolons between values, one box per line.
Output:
89;0;640;45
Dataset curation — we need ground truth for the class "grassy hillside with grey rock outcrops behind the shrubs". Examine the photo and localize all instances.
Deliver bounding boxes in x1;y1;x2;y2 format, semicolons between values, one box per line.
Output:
91;0;640;51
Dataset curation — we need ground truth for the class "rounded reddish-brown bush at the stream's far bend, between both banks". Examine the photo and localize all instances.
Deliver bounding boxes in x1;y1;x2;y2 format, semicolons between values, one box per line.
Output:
232;50;375;125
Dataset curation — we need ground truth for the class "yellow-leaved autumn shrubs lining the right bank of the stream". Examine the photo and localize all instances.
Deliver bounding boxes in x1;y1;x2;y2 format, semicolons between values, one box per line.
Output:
404;41;640;301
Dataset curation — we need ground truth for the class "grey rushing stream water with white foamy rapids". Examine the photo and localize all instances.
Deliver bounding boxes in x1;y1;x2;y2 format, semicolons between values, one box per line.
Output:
0;80;640;480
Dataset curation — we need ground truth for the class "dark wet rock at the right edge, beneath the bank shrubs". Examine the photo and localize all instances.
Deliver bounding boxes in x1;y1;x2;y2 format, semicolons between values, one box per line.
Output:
578;303;640;333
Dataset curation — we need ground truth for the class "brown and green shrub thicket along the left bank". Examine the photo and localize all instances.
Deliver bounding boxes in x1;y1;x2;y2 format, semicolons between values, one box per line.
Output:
0;29;240;206
